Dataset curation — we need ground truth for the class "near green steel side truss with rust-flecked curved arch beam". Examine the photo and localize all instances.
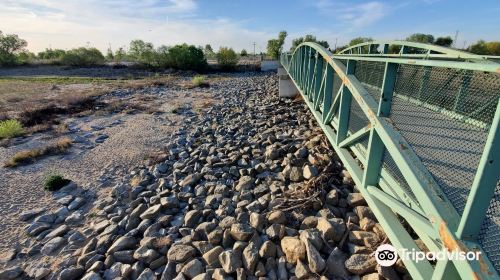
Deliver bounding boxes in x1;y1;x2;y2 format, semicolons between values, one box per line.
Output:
281;41;500;279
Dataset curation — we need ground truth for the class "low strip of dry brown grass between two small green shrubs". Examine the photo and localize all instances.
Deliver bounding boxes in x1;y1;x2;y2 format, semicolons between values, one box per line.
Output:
4;137;73;167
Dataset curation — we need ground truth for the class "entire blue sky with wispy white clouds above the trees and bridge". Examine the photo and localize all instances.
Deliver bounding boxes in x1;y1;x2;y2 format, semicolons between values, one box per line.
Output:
0;0;500;51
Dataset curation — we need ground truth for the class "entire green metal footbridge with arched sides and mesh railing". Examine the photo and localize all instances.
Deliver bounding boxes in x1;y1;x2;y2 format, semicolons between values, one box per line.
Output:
281;41;500;279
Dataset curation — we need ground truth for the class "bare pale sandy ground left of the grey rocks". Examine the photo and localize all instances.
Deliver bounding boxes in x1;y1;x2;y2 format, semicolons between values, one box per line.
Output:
0;79;216;249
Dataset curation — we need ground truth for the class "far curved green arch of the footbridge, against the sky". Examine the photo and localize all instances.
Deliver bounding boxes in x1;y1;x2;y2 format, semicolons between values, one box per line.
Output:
336;40;494;62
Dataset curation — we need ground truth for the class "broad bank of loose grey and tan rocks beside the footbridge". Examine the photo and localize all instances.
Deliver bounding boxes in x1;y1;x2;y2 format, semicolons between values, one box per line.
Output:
0;74;408;280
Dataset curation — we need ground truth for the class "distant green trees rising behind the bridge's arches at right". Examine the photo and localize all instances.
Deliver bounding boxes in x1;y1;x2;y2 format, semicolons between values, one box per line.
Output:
267;31;500;59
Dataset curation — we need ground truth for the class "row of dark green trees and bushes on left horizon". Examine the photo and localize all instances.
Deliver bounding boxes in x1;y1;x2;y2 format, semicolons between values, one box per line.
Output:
0;31;248;71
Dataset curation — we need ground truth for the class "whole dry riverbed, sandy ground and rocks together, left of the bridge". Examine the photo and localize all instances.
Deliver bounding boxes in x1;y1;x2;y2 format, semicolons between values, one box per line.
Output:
0;68;409;279
